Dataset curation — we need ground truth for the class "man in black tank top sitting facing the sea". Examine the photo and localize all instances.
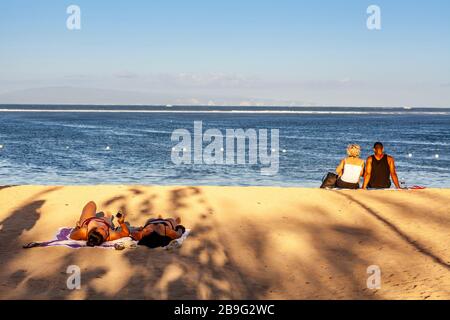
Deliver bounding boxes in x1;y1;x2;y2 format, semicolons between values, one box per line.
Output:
363;142;400;189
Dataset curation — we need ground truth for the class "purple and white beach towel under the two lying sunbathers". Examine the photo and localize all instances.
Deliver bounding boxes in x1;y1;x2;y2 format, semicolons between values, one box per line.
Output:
23;227;190;250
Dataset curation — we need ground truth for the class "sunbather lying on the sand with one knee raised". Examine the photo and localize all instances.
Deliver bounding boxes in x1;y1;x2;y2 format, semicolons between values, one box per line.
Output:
70;201;130;247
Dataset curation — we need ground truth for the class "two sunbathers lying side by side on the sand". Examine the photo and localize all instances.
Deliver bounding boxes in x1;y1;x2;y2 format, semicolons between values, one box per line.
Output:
70;201;185;248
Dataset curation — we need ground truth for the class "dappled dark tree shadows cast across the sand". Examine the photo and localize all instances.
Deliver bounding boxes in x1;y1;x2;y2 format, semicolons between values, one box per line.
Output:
0;187;449;299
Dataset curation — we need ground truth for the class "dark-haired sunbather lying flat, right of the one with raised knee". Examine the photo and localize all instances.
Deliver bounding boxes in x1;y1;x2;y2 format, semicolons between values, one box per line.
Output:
131;217;186;248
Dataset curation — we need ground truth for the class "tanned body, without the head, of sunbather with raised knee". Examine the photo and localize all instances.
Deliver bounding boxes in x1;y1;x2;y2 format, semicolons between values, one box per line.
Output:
70;201;130;241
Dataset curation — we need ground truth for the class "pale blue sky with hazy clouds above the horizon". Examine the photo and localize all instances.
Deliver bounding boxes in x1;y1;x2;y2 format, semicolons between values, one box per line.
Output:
0;0;450;107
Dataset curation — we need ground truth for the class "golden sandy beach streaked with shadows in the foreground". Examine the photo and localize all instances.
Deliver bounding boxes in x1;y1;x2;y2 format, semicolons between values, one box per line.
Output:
0;185;450;299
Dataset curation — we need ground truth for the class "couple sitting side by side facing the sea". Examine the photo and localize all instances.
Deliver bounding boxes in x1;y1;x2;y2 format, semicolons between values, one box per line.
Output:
336;142;400;189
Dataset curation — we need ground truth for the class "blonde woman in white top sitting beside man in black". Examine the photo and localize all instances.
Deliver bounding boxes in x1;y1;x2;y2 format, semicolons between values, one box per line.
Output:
336;144;364;189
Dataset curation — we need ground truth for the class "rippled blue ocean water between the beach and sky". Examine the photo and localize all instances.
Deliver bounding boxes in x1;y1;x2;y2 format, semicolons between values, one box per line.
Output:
0;105;450;187
